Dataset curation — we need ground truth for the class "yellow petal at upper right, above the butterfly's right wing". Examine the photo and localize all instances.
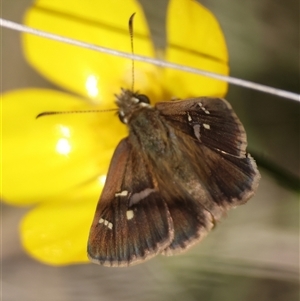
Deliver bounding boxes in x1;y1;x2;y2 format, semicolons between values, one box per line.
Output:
165;0;228;98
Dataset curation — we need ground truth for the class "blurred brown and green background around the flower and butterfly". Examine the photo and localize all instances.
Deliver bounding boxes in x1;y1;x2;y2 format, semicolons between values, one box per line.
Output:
1;0;300;301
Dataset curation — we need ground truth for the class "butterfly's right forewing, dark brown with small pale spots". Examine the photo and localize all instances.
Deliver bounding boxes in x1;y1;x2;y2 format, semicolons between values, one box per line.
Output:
156;97;247;157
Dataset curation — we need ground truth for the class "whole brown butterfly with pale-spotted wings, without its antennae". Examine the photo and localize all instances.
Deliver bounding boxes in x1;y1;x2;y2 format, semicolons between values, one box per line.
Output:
88;90;260;266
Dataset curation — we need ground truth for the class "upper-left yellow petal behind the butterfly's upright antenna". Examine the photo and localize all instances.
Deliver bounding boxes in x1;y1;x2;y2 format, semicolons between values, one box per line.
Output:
24;0;162;104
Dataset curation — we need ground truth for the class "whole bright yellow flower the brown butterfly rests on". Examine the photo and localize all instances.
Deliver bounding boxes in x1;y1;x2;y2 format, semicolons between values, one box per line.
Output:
1;0;228;265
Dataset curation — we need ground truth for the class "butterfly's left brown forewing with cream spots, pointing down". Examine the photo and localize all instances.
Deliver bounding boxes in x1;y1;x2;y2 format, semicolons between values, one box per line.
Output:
88;139;174;266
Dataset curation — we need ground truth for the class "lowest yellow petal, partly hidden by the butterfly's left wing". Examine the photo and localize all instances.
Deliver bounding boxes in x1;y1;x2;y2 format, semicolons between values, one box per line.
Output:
21;198;96;265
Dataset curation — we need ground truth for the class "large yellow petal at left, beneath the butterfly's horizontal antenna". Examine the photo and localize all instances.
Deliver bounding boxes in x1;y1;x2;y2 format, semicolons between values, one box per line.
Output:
1;89;126;205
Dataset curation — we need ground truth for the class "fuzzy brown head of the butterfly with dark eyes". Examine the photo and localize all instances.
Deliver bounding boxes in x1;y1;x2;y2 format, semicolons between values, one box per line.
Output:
115;88;151;124
